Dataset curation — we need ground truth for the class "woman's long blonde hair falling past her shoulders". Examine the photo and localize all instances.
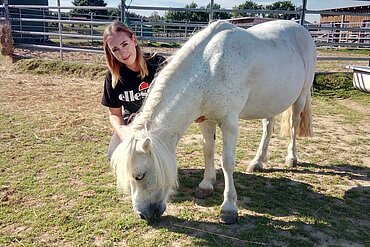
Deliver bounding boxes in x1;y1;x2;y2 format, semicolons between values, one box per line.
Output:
103;20;149;88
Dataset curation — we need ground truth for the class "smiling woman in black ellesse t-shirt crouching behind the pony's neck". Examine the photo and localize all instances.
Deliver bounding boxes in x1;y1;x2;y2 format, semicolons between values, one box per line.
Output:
102;21;165;159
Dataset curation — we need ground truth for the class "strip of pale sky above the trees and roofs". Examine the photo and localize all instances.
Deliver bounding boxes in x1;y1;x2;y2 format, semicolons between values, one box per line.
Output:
49;0;370;21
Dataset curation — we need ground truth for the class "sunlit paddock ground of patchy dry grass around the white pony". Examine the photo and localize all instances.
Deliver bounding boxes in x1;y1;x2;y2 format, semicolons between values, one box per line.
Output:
0;57;370;246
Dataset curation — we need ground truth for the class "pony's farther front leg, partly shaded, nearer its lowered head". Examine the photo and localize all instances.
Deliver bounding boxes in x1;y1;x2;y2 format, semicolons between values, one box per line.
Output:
195;121;216;199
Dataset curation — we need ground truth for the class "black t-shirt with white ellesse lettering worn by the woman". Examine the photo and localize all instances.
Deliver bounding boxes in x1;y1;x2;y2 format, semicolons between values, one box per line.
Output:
101;54;165;113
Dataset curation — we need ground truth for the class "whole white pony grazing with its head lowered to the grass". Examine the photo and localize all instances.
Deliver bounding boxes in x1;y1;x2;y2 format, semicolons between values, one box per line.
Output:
112;21;316;223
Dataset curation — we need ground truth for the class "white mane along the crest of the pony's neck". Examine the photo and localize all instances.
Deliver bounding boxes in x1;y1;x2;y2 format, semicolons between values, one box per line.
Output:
132;21;233;130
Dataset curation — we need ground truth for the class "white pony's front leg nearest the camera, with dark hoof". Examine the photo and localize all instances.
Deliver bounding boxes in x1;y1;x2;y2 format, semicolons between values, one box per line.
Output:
220;113;238;224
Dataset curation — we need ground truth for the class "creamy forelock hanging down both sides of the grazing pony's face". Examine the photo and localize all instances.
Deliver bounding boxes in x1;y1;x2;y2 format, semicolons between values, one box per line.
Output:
111;129;178;194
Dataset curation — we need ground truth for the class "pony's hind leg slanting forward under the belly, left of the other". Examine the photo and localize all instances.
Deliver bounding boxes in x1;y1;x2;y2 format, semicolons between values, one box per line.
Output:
247;117;275;172
